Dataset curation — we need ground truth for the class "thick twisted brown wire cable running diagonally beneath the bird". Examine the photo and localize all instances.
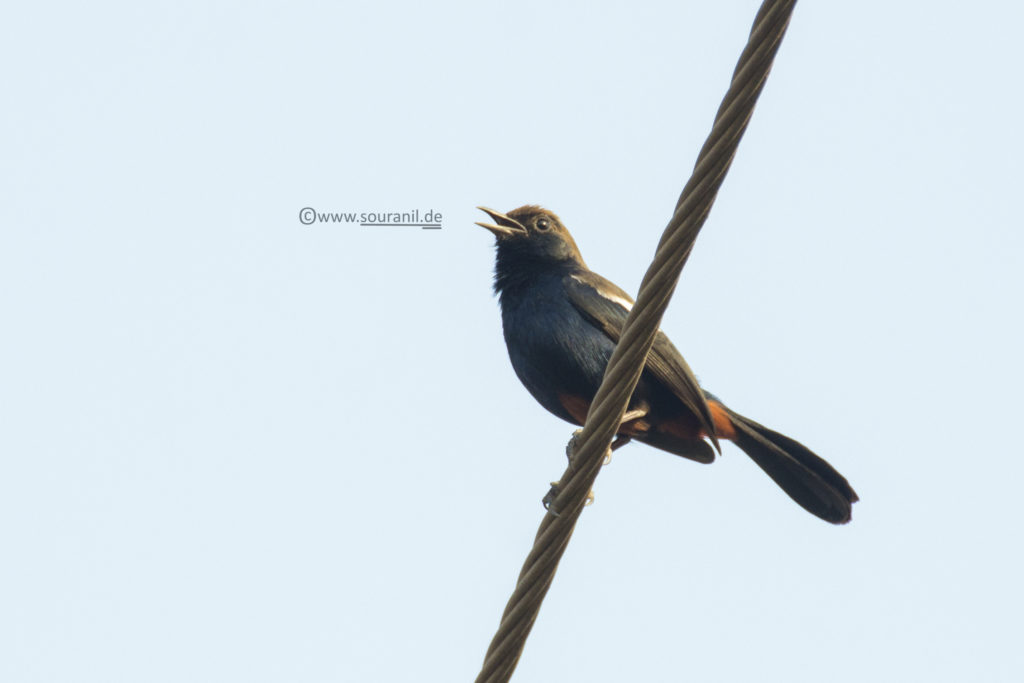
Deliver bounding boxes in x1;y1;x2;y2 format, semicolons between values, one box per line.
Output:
476;0;796;683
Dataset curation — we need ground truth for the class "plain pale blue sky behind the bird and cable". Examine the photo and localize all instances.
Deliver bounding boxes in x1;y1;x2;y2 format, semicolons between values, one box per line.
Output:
0;1;1024;683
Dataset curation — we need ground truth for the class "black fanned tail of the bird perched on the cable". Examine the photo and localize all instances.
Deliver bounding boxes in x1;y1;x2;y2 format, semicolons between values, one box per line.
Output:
726;409;857;524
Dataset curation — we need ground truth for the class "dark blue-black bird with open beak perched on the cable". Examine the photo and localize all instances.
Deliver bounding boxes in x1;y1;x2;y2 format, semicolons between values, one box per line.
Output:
476;205;858;524
